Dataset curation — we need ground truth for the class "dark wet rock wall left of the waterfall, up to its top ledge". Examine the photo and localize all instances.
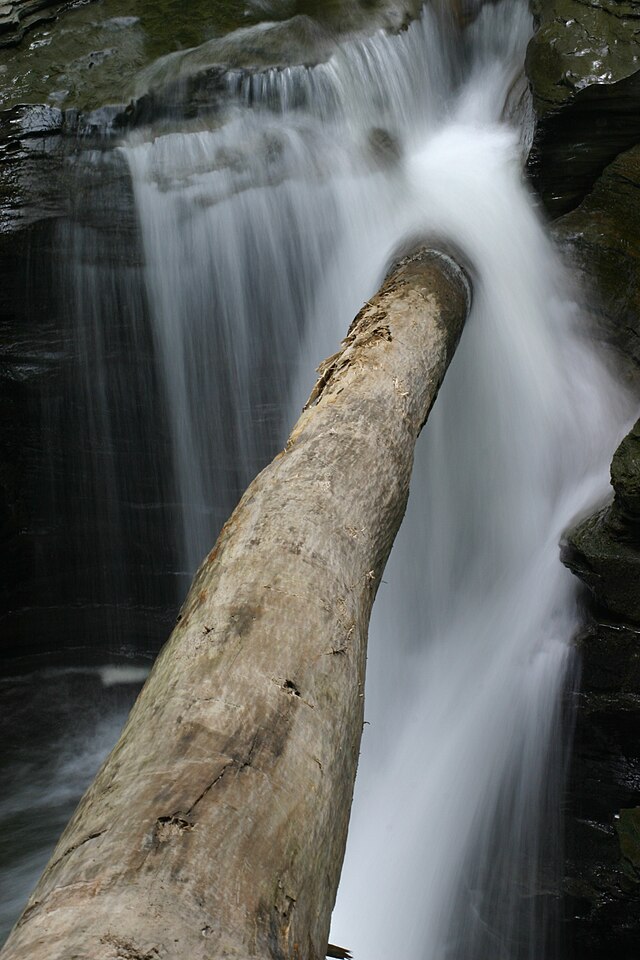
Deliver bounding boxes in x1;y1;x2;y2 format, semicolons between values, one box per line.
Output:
0;0;436;658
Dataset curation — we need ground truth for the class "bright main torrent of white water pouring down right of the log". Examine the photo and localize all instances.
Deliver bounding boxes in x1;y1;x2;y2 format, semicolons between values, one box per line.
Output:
334;114;621;960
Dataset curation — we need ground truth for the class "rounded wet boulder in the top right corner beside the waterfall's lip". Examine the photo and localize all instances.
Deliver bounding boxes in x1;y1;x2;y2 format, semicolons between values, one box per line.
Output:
526;0;640;217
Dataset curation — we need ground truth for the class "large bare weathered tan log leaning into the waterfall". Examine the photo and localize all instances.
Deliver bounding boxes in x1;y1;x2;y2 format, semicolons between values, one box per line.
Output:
2;249;469;960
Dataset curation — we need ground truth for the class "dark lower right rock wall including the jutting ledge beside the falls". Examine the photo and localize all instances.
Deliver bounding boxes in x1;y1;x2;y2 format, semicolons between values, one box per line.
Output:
563;421;640;960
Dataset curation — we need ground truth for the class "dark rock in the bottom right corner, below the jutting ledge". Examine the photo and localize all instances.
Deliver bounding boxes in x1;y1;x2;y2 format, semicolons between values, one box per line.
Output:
563;621;640;960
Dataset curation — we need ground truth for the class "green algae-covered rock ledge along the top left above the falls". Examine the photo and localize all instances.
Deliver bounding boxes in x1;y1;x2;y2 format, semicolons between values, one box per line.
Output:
0;0;421;111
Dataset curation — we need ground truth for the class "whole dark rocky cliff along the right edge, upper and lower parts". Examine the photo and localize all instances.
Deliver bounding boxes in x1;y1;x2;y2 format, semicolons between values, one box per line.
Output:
527;0;640;960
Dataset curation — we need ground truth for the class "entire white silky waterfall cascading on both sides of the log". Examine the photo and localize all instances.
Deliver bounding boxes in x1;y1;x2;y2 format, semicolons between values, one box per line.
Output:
1;0;636;960
